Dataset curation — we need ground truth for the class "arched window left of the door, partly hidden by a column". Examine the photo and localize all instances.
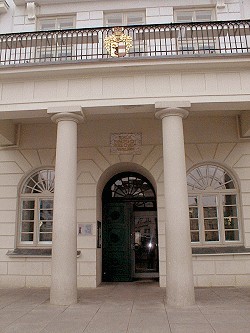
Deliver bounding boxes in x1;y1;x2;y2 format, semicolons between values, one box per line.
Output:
18;169;55;246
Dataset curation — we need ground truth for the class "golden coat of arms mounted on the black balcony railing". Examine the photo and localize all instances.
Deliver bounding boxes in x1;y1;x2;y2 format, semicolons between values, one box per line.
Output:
104;27;133;58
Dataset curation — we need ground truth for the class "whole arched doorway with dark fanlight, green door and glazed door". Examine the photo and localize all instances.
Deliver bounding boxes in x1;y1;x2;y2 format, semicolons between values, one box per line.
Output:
102;172;159;281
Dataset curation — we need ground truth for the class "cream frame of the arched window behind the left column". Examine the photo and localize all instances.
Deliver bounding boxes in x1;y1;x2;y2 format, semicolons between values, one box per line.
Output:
16;167;55;248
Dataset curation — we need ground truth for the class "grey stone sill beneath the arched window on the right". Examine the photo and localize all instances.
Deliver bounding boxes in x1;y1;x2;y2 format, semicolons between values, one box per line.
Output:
192;246;250;255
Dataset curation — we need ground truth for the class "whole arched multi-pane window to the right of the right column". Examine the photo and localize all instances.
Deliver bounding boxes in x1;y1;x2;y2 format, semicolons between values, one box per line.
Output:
187;164;240;245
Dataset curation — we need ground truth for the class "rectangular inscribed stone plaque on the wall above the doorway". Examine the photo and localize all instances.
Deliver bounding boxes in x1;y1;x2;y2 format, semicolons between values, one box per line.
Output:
110;133;142;154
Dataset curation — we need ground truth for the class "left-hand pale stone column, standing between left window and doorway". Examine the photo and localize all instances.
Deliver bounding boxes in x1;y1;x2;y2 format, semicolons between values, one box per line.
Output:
50;113;83;305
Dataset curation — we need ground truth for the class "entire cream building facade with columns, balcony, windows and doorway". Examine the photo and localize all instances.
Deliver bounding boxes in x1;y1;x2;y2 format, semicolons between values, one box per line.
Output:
0;0;250;305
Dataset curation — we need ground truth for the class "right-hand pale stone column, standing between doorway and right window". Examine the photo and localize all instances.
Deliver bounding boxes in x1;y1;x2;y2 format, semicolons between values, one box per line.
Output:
156;108;195;307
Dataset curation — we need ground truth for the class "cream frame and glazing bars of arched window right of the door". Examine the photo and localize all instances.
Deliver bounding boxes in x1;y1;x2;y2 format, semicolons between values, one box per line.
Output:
187;162;243;247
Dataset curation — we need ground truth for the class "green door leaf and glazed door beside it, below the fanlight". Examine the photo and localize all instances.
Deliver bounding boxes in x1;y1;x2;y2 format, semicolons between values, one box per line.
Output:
102;202;159;282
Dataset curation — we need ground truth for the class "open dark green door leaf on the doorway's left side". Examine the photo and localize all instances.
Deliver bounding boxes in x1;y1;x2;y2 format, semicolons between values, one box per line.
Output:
102;203;132;282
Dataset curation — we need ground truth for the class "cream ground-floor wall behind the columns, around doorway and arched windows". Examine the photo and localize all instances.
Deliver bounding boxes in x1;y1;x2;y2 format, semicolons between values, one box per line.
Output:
0;116;250;287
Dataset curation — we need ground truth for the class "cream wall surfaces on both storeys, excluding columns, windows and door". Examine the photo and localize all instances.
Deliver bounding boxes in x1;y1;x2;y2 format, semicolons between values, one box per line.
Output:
0;0;250;287
